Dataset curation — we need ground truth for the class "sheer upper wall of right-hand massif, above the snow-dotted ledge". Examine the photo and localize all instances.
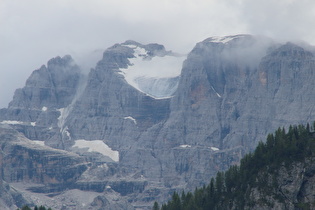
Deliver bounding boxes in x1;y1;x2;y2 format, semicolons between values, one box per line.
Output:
158;35;315;151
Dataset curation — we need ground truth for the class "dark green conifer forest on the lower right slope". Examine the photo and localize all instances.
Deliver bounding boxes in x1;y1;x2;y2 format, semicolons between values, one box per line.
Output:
153;122;315;210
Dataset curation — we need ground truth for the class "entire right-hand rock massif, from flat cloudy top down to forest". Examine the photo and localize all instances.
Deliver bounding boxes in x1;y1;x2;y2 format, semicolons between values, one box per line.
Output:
119;35;315;195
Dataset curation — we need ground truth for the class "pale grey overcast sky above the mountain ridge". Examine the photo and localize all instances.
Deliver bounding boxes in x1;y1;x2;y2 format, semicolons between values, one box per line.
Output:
0;0;315;108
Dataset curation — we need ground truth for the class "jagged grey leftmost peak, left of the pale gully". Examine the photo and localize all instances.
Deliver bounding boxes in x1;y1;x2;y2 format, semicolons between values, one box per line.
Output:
9;56;80;110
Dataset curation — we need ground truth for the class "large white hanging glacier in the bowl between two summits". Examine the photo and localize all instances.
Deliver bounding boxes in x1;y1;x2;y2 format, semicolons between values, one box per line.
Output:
119;45;186;99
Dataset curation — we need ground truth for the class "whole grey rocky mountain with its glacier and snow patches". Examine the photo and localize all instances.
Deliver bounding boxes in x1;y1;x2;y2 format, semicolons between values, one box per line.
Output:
0;35;315;209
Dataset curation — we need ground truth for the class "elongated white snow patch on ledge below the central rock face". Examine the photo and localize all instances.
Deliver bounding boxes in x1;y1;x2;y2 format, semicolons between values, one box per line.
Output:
72;139;119;162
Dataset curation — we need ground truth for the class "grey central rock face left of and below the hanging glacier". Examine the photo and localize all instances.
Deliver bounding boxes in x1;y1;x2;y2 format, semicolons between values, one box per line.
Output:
59;41;173;149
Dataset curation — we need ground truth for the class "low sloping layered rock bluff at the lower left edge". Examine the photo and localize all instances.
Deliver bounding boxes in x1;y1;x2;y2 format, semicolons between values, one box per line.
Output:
0;128;87;184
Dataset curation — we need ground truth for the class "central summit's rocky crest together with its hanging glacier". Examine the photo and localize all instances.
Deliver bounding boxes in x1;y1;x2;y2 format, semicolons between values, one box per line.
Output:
95;40;185;99
